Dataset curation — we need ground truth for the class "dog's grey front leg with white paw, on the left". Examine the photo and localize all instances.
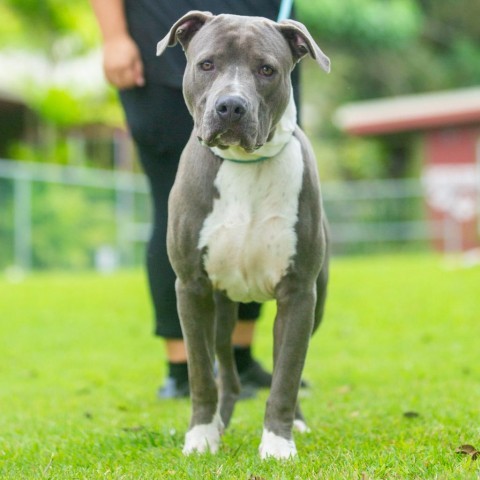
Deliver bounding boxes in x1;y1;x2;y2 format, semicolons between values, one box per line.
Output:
176;279;223;455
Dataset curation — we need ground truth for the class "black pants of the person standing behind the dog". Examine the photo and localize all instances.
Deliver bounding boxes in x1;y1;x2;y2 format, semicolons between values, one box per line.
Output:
120;83;260;338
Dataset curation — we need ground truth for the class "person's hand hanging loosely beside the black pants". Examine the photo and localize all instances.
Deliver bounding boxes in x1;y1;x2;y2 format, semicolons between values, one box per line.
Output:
103;35;145;90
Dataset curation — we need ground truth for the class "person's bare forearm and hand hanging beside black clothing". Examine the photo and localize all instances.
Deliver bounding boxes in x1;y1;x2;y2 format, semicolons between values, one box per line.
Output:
90;0;145;89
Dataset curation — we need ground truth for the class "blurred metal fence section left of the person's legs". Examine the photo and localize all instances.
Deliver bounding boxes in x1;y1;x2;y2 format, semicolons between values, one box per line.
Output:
0;160;150;270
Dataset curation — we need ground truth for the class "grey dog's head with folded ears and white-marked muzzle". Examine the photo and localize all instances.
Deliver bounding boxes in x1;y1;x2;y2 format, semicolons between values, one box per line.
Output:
157;11;330;152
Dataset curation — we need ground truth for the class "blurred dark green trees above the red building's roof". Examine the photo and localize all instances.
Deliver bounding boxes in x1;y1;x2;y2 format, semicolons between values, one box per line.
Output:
297;0;480;100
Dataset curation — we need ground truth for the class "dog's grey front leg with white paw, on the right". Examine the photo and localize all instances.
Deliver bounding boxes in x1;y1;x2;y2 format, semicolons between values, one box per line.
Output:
259;282;316;459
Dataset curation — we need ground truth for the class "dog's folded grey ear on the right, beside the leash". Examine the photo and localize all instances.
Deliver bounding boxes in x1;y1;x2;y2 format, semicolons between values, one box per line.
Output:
278;20;330;73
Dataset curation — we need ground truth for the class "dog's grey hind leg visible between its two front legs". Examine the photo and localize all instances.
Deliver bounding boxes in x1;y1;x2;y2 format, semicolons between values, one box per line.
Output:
215;293;240;426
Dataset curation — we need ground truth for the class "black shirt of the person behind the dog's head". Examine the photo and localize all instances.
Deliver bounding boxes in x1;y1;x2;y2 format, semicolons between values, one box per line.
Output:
124;0;286;88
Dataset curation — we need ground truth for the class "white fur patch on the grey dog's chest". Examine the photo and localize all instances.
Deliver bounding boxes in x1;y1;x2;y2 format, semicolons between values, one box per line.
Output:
198;137;303;302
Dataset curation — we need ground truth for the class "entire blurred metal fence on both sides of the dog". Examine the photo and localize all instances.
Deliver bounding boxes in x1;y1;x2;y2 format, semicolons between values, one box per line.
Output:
0;160;466;270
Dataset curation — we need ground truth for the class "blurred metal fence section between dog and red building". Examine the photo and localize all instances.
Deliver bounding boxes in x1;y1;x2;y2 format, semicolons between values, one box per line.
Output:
322;179;441;252
